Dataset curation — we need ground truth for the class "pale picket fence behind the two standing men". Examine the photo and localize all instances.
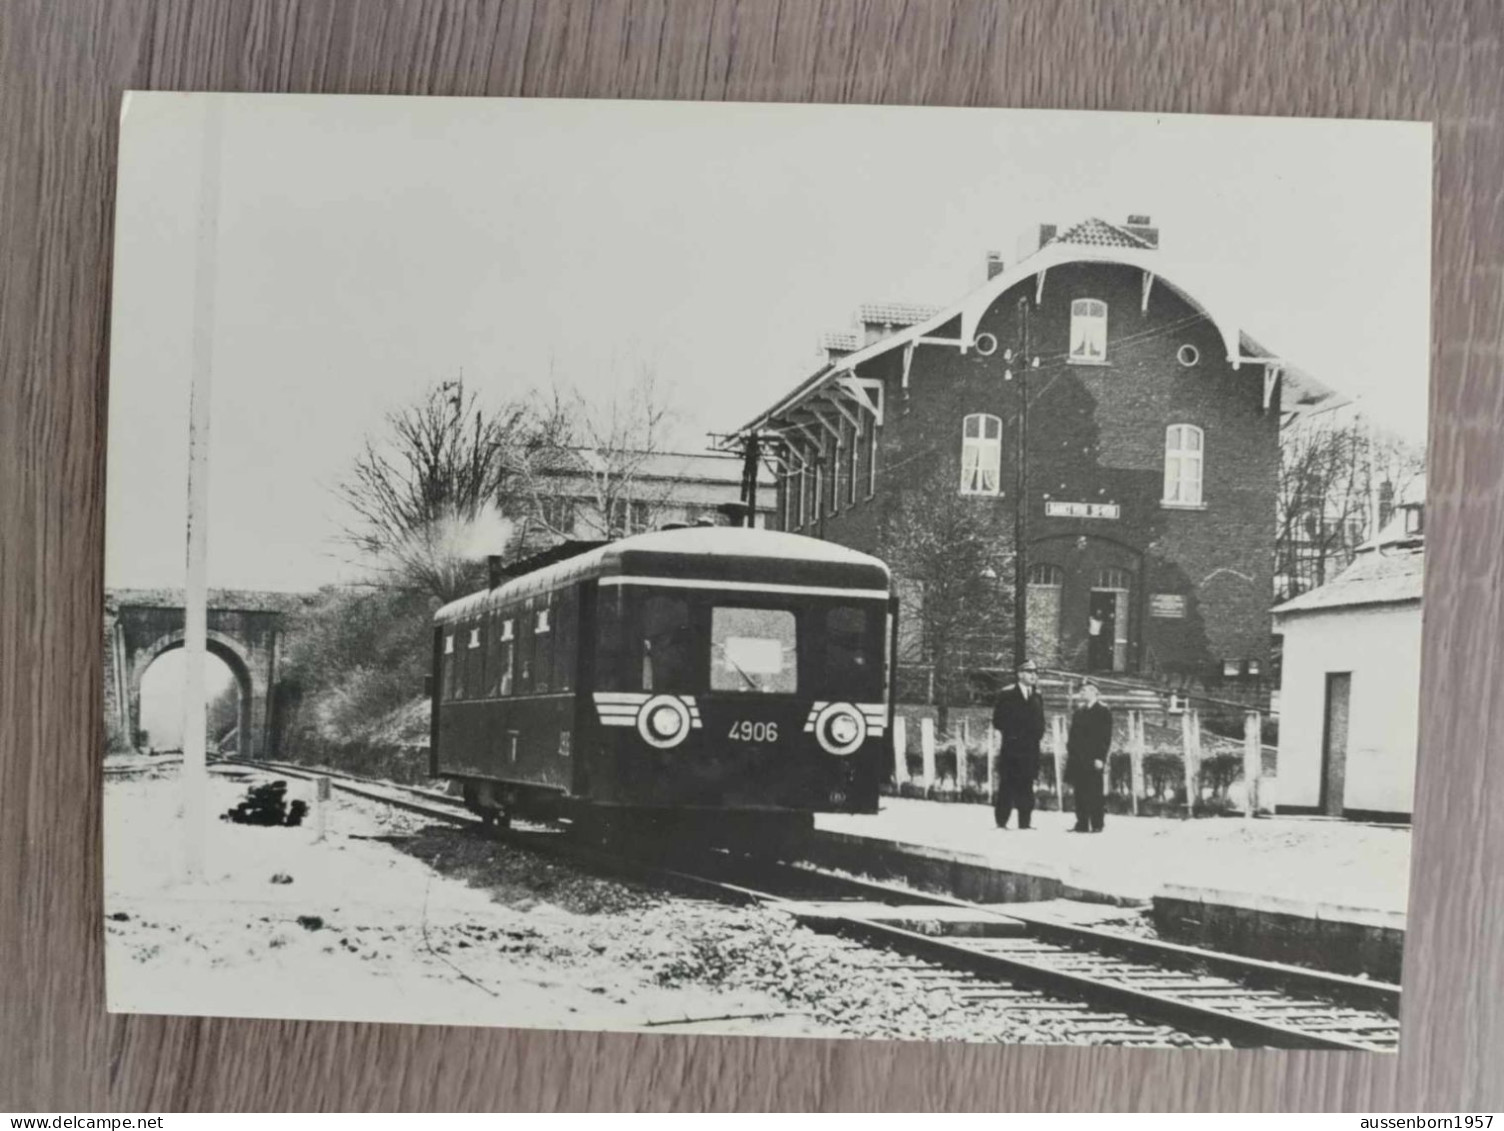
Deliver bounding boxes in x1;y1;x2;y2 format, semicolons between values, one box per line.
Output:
893;707;1275;817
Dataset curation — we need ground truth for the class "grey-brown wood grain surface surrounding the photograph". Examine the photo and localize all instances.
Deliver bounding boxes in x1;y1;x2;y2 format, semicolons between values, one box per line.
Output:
0;0;1504;1111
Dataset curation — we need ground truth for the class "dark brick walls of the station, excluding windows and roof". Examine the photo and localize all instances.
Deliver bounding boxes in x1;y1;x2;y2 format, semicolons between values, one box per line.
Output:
776;263;1278;680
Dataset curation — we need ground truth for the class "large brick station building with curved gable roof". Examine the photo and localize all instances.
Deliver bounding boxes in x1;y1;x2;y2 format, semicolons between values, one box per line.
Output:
738;217;1334;686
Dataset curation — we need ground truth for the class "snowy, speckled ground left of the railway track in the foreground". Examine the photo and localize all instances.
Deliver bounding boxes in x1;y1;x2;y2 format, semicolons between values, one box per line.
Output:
105;769;1206;1044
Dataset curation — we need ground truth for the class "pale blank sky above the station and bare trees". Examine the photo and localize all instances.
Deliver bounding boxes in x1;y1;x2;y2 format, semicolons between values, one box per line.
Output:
105;93;1432;590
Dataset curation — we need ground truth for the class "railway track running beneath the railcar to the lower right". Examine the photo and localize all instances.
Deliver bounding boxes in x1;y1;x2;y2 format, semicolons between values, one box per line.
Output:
222;763;1400;1051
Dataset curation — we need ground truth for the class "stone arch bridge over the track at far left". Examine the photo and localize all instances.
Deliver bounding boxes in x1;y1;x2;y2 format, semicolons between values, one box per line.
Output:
104;590;305;758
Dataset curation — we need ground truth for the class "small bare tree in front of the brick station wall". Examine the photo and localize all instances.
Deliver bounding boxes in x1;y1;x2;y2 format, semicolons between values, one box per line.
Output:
883;462;1014;729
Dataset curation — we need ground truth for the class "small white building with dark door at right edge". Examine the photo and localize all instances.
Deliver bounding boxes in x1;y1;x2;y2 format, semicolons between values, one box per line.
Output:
1274;483;1426;820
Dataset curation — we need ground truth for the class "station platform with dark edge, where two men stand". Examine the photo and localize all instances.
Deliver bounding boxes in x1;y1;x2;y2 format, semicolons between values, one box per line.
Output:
817;797;1411;981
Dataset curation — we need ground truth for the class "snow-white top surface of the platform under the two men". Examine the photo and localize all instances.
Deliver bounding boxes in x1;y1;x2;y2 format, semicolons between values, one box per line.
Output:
817;797;1411;913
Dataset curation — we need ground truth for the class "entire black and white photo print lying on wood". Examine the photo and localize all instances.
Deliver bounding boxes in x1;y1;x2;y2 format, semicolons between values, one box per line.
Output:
106;92;1432;1051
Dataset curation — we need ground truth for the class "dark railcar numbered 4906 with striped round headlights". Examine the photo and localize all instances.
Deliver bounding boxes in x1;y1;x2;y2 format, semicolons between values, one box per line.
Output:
430;526;896;836
